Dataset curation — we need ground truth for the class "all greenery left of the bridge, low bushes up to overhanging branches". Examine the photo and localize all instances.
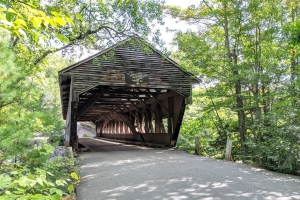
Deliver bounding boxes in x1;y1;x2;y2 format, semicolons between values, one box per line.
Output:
0;0;162;200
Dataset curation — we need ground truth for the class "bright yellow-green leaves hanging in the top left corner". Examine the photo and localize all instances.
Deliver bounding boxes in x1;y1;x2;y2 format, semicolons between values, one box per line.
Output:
0;1;74;44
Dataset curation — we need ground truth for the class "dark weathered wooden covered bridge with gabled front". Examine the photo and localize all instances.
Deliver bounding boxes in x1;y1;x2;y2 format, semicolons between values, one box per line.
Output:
58;37;199;149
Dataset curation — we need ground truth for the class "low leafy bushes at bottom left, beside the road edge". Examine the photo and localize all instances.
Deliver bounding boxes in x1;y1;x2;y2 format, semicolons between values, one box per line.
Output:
0;152;79;199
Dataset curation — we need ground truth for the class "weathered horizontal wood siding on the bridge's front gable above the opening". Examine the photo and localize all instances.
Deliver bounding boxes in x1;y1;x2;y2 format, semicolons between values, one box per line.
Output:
64;44;191;97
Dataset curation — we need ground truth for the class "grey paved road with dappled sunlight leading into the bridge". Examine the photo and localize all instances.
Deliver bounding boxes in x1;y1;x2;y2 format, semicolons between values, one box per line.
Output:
77;139;300;200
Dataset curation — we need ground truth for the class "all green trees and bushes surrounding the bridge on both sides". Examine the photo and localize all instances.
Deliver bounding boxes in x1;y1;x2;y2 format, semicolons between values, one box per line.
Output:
0;0;300;199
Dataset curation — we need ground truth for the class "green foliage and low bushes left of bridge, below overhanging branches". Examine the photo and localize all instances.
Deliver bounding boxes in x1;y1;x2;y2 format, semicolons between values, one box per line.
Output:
0;31;78;199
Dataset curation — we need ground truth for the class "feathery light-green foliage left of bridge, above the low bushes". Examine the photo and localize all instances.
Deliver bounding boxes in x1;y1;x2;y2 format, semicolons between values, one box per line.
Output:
0;28;64;163
